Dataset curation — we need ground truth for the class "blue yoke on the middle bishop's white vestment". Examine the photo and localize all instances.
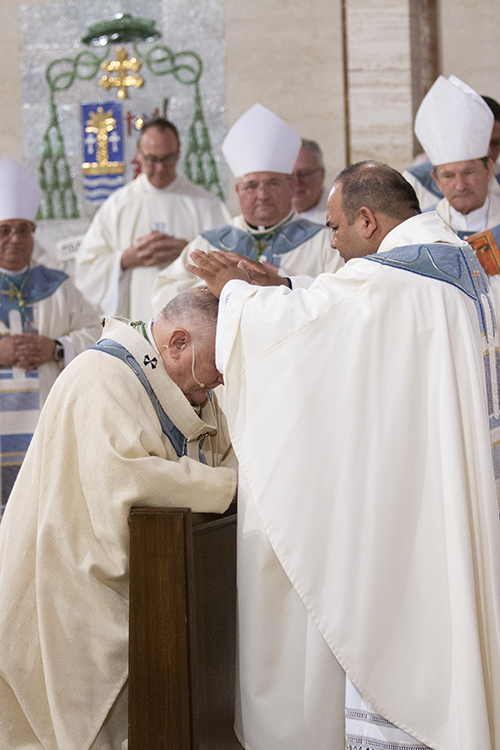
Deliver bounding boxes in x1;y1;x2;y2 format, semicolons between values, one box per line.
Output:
201;219;324;266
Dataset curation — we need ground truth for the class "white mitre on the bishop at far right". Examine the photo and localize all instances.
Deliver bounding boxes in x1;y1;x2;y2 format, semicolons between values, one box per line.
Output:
415;76;495;165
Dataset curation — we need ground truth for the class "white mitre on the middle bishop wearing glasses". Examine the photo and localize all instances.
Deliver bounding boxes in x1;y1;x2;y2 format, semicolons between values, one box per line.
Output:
222;104;302;177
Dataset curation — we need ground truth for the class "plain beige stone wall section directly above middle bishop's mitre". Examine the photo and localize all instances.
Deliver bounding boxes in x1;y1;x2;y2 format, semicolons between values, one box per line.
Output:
226;0;345;212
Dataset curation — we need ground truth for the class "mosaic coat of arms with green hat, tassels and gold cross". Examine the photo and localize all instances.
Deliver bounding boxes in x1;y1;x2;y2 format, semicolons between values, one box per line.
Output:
30;9;223;219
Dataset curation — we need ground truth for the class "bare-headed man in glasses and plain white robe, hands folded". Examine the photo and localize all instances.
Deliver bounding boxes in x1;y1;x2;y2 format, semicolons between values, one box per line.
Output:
75;117;230;320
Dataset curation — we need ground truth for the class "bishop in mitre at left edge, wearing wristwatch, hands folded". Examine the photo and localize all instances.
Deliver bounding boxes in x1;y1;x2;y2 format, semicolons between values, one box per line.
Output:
0;157;101;512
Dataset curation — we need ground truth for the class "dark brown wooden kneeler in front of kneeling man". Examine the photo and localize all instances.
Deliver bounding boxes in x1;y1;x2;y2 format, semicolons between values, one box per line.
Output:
129;507;241;750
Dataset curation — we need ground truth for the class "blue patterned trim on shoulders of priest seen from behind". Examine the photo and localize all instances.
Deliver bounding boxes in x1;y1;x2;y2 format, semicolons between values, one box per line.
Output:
366;243;500;486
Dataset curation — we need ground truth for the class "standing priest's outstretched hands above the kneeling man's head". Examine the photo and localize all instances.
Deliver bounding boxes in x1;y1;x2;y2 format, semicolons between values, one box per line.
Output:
186;250;289;297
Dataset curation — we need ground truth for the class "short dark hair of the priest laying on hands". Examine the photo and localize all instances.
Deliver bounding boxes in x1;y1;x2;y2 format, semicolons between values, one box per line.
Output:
333;161;421;224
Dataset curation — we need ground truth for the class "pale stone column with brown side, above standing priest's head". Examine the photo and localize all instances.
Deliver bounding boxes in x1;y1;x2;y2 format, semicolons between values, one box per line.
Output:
343;0;438;170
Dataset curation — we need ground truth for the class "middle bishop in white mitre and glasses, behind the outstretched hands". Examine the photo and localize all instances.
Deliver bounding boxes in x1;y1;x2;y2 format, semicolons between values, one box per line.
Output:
149;104;344;311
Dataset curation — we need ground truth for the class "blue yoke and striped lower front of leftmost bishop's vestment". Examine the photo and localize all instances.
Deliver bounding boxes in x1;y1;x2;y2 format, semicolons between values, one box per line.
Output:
0;266;68;513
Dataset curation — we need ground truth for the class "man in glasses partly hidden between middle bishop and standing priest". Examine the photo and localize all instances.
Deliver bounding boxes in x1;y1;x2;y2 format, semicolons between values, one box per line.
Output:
293;138;328;224
